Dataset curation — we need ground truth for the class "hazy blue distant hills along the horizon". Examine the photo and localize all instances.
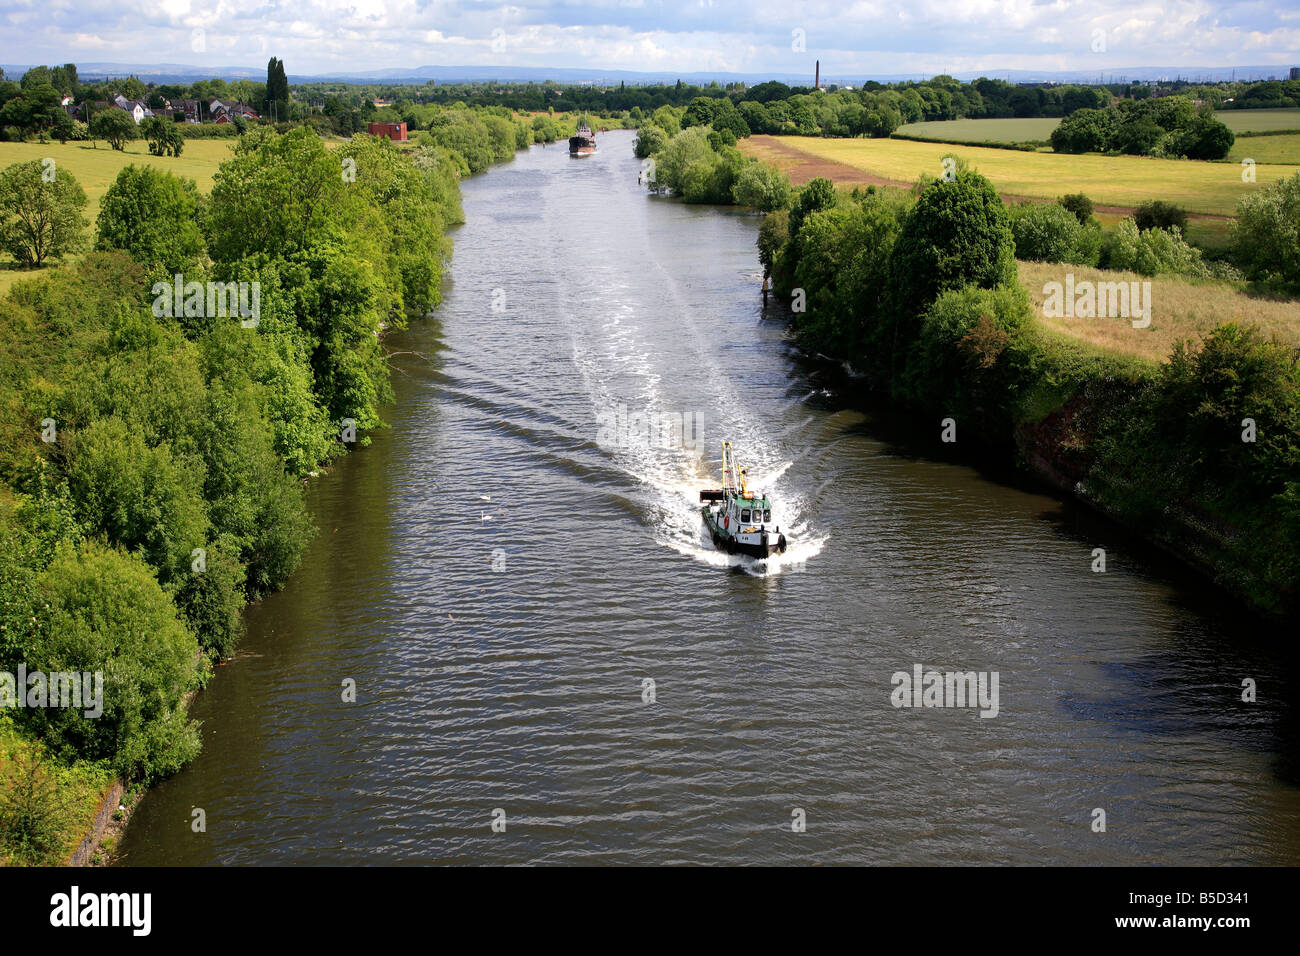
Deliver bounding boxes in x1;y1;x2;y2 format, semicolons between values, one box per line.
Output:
0;62;1290;86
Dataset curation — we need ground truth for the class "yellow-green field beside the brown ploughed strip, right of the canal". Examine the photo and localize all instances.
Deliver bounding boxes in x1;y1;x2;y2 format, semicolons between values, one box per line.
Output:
741;137;1300;216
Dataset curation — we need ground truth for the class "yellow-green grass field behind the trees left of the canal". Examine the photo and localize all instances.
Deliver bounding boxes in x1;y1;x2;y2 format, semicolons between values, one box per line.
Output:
0;139;235;295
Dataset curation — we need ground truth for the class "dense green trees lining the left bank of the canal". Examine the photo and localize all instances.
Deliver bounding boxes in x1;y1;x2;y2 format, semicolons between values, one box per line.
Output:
0;127;491;806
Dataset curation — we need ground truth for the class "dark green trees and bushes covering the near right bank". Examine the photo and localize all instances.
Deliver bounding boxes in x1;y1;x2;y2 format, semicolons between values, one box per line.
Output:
758;164;1300;614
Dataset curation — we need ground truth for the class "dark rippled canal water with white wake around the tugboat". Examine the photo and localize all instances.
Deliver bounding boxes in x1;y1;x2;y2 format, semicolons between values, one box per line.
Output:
122;131;1300;864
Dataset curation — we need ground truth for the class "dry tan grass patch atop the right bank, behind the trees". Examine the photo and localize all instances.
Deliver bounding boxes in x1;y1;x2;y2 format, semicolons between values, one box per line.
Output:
1018;261;1300;362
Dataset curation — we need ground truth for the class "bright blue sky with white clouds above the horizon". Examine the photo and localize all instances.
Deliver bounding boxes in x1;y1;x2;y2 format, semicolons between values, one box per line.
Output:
0;0;1300;81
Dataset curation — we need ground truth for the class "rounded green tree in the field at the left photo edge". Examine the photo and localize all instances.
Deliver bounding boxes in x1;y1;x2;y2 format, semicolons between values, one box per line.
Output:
0;160;87;268
